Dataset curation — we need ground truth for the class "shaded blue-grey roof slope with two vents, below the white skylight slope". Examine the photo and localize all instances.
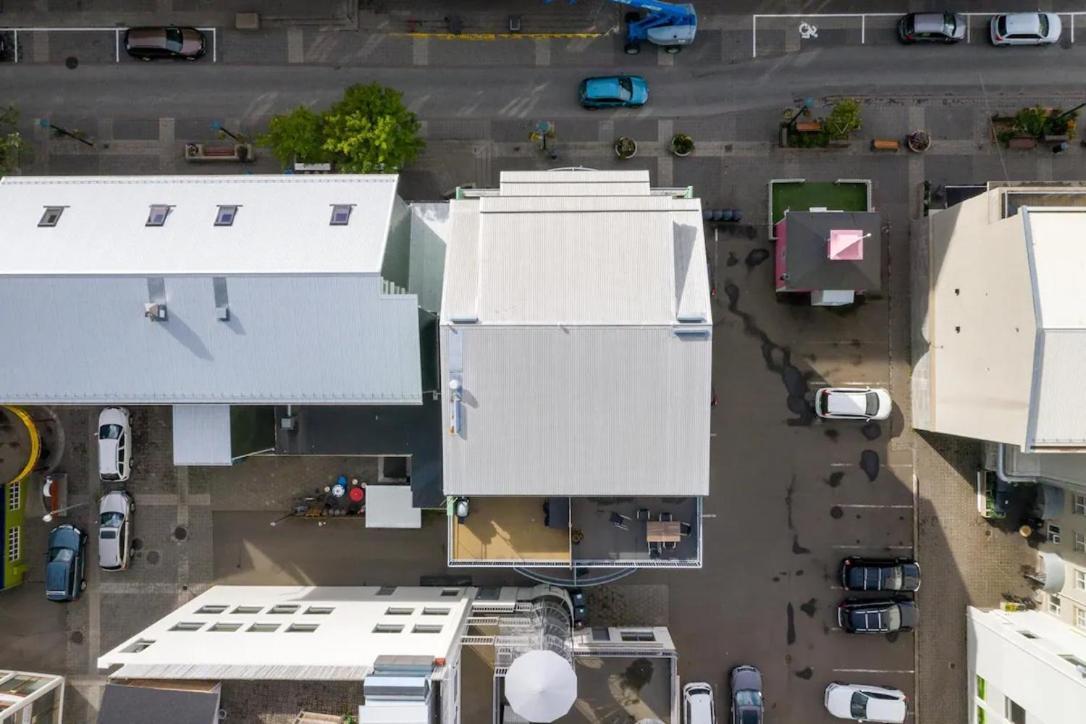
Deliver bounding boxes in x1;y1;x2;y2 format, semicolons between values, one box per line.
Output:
0;275;421;404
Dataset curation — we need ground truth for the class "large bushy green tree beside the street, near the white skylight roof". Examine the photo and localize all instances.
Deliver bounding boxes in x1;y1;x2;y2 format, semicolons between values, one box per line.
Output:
257;84;425;174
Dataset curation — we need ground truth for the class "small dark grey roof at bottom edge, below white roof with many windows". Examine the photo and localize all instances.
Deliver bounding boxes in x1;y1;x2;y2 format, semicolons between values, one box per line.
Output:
98;684;219;724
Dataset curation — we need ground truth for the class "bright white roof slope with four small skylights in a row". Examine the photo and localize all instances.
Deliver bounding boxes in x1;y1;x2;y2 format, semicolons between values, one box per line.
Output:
0;174;397;276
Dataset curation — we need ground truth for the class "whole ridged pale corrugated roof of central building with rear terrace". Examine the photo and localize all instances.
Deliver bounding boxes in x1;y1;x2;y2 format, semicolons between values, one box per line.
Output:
441;172;712;495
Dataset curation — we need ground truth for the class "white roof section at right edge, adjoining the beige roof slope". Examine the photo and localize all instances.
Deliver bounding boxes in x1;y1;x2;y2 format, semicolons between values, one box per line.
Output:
1022;208;1086;446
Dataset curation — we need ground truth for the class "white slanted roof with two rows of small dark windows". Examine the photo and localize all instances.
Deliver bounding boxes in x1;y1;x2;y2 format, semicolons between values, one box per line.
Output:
98;586;475;681
